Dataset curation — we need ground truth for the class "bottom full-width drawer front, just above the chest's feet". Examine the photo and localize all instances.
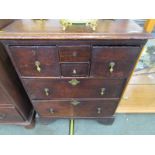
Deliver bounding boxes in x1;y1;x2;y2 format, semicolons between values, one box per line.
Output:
33;100;118;117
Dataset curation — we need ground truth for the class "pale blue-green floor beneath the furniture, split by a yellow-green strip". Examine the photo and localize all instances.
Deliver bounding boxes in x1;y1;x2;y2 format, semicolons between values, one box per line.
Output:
0;114;155;135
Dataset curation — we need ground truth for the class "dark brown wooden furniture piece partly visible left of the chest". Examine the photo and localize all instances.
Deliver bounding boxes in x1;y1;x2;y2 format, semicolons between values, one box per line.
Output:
0;44;34;128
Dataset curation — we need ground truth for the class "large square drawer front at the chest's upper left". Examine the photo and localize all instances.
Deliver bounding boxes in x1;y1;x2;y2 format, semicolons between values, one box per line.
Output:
10;46;60;77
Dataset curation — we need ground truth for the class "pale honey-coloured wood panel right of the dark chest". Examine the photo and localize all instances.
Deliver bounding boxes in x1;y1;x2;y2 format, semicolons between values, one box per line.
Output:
116;84;155;113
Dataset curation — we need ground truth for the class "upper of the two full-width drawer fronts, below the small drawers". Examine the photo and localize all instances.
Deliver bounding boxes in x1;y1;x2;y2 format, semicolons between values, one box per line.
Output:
23;79;125;100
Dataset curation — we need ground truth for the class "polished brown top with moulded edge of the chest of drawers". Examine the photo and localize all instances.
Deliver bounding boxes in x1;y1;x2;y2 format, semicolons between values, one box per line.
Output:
0;19;152;40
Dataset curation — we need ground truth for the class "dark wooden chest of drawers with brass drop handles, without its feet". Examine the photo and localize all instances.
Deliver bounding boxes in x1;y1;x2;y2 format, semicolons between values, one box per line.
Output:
1;20;150;123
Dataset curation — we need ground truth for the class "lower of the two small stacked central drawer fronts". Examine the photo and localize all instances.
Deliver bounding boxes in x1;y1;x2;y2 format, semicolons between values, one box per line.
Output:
61;63;89;77
